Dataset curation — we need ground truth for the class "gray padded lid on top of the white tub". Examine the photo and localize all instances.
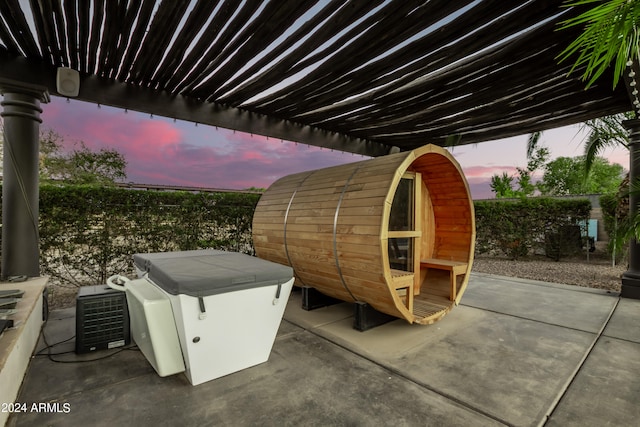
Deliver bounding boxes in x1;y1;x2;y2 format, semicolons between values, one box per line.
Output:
133;250;293;297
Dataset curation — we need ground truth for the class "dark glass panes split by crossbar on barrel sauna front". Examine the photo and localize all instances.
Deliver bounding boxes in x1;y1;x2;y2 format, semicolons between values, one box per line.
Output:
388;174;416;271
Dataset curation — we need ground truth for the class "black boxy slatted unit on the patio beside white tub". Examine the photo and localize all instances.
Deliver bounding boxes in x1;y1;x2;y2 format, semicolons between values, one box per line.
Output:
76;285;131;353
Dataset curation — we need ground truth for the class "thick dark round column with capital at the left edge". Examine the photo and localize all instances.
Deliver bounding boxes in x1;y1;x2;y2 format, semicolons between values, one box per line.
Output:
0;79;49;280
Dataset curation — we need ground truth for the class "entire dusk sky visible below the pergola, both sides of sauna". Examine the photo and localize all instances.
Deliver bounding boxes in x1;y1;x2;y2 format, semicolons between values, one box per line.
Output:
12;97;629;199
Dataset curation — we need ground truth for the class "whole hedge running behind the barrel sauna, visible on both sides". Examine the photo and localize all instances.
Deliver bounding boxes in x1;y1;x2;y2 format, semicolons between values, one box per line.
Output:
0;185;591;286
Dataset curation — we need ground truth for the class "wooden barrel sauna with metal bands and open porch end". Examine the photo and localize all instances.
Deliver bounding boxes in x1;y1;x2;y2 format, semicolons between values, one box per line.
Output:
253;145;475;324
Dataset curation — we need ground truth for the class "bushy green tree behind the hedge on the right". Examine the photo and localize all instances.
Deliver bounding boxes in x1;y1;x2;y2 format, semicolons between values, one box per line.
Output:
538;156;624;196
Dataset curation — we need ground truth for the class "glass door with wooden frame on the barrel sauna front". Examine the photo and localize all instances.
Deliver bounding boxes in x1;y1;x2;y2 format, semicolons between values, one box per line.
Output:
388;172;422;305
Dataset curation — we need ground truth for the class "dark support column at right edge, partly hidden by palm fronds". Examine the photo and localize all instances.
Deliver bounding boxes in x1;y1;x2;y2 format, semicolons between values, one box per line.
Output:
621;119;640;299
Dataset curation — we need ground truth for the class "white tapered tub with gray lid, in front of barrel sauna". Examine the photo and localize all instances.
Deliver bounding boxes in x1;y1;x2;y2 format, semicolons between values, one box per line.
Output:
132;250;293;385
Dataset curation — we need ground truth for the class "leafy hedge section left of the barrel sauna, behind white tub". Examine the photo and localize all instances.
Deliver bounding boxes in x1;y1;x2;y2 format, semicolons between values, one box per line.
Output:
0;185;260;286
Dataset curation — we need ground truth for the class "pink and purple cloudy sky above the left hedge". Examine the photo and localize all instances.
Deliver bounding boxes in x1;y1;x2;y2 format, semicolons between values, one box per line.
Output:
36;98;364;189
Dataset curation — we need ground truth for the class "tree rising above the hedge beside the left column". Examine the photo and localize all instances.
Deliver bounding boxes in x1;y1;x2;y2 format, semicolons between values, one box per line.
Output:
40;130;127;185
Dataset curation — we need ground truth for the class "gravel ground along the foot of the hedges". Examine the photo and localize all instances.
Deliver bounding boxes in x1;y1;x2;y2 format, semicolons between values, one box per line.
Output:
49;244;627;310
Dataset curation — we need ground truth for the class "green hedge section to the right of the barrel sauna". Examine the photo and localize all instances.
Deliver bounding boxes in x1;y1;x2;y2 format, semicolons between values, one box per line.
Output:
475;198;591;260
